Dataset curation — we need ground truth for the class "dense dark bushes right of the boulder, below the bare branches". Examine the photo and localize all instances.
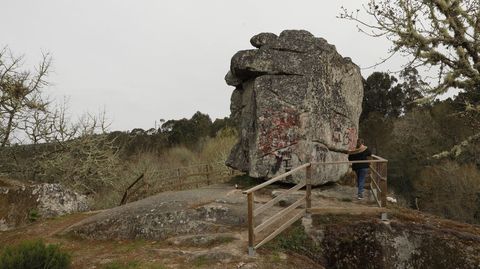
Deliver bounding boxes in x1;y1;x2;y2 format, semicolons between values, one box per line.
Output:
360;68;480;223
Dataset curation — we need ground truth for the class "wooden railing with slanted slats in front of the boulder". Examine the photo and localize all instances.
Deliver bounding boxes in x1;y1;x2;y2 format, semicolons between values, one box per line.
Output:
243;155;388;255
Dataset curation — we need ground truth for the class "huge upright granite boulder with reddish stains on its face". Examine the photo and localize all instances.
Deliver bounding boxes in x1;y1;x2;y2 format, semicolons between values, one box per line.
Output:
225;30;363;184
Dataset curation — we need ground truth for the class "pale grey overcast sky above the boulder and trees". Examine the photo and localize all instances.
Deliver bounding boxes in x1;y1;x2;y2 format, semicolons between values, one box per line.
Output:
0;0;401;130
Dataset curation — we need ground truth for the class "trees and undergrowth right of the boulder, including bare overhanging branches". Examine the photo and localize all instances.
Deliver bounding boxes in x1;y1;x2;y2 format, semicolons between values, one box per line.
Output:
339;0;480;223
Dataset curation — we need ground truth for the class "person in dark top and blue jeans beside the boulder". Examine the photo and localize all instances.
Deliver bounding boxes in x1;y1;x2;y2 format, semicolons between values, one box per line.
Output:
348;138;372;200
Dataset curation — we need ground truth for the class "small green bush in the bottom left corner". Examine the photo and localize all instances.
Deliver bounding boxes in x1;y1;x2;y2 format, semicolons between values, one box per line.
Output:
0;240;71;269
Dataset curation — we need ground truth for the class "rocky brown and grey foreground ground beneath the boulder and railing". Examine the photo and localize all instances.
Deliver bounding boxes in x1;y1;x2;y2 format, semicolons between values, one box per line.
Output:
0;178;480;268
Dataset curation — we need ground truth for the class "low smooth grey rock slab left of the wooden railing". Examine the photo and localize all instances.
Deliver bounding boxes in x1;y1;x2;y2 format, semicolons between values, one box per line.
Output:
64;185;246;240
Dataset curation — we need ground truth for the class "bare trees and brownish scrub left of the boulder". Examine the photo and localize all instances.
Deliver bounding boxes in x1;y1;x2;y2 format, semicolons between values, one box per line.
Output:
0;48;236;208
